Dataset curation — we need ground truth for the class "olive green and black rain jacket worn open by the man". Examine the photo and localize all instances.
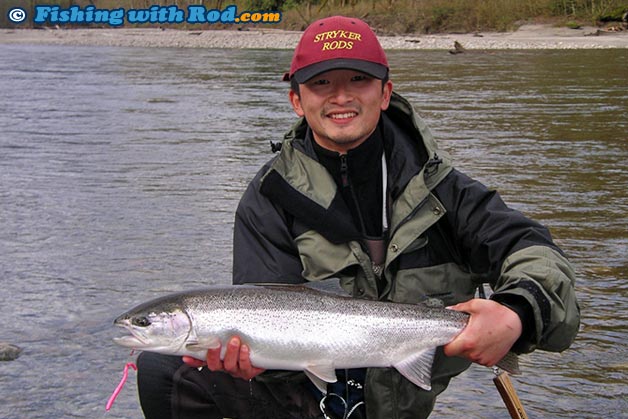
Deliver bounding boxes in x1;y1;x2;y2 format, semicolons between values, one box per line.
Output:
233;93;579;419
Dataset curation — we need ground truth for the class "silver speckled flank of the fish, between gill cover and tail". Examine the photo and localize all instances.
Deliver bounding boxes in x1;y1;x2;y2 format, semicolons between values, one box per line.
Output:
181;286;468;369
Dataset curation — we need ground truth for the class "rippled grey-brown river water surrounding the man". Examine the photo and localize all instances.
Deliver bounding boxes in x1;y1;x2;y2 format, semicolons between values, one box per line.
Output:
0;45;628;419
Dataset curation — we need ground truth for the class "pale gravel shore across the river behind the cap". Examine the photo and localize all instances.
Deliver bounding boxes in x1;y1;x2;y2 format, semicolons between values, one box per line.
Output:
0;25;628;52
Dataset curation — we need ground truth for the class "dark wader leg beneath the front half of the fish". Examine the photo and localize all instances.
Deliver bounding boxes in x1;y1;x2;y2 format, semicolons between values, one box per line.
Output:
137;352;323;419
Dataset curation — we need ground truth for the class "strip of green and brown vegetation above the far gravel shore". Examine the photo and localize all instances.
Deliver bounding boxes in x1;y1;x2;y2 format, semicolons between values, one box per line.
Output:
0;0;628;34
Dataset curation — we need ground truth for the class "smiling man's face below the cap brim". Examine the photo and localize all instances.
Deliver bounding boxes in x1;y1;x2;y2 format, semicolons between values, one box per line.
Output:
290;70;392;154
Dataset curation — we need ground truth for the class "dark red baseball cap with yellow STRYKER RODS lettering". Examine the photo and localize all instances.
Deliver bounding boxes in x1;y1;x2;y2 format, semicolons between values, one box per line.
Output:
284;16;388;83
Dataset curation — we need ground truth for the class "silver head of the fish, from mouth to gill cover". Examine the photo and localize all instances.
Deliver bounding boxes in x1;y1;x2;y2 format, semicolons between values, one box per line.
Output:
113;304;192;355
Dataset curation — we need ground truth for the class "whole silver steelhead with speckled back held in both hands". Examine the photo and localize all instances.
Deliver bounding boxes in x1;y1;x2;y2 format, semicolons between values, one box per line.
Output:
114;281;516;392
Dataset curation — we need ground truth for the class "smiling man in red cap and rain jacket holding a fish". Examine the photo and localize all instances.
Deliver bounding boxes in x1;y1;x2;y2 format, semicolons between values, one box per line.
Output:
139;16;579;418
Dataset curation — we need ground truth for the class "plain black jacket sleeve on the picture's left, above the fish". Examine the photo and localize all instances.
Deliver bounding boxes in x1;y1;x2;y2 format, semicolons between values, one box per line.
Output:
233;169;304;284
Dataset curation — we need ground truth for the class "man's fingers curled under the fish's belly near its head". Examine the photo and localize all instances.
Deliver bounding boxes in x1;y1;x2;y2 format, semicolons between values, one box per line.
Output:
183;336;265;380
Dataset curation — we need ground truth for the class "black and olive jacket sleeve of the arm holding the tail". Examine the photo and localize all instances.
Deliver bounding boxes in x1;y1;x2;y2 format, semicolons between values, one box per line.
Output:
435;170;580;353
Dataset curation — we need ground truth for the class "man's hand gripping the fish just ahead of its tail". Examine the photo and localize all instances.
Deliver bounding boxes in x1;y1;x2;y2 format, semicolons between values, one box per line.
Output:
443;298;522;367
